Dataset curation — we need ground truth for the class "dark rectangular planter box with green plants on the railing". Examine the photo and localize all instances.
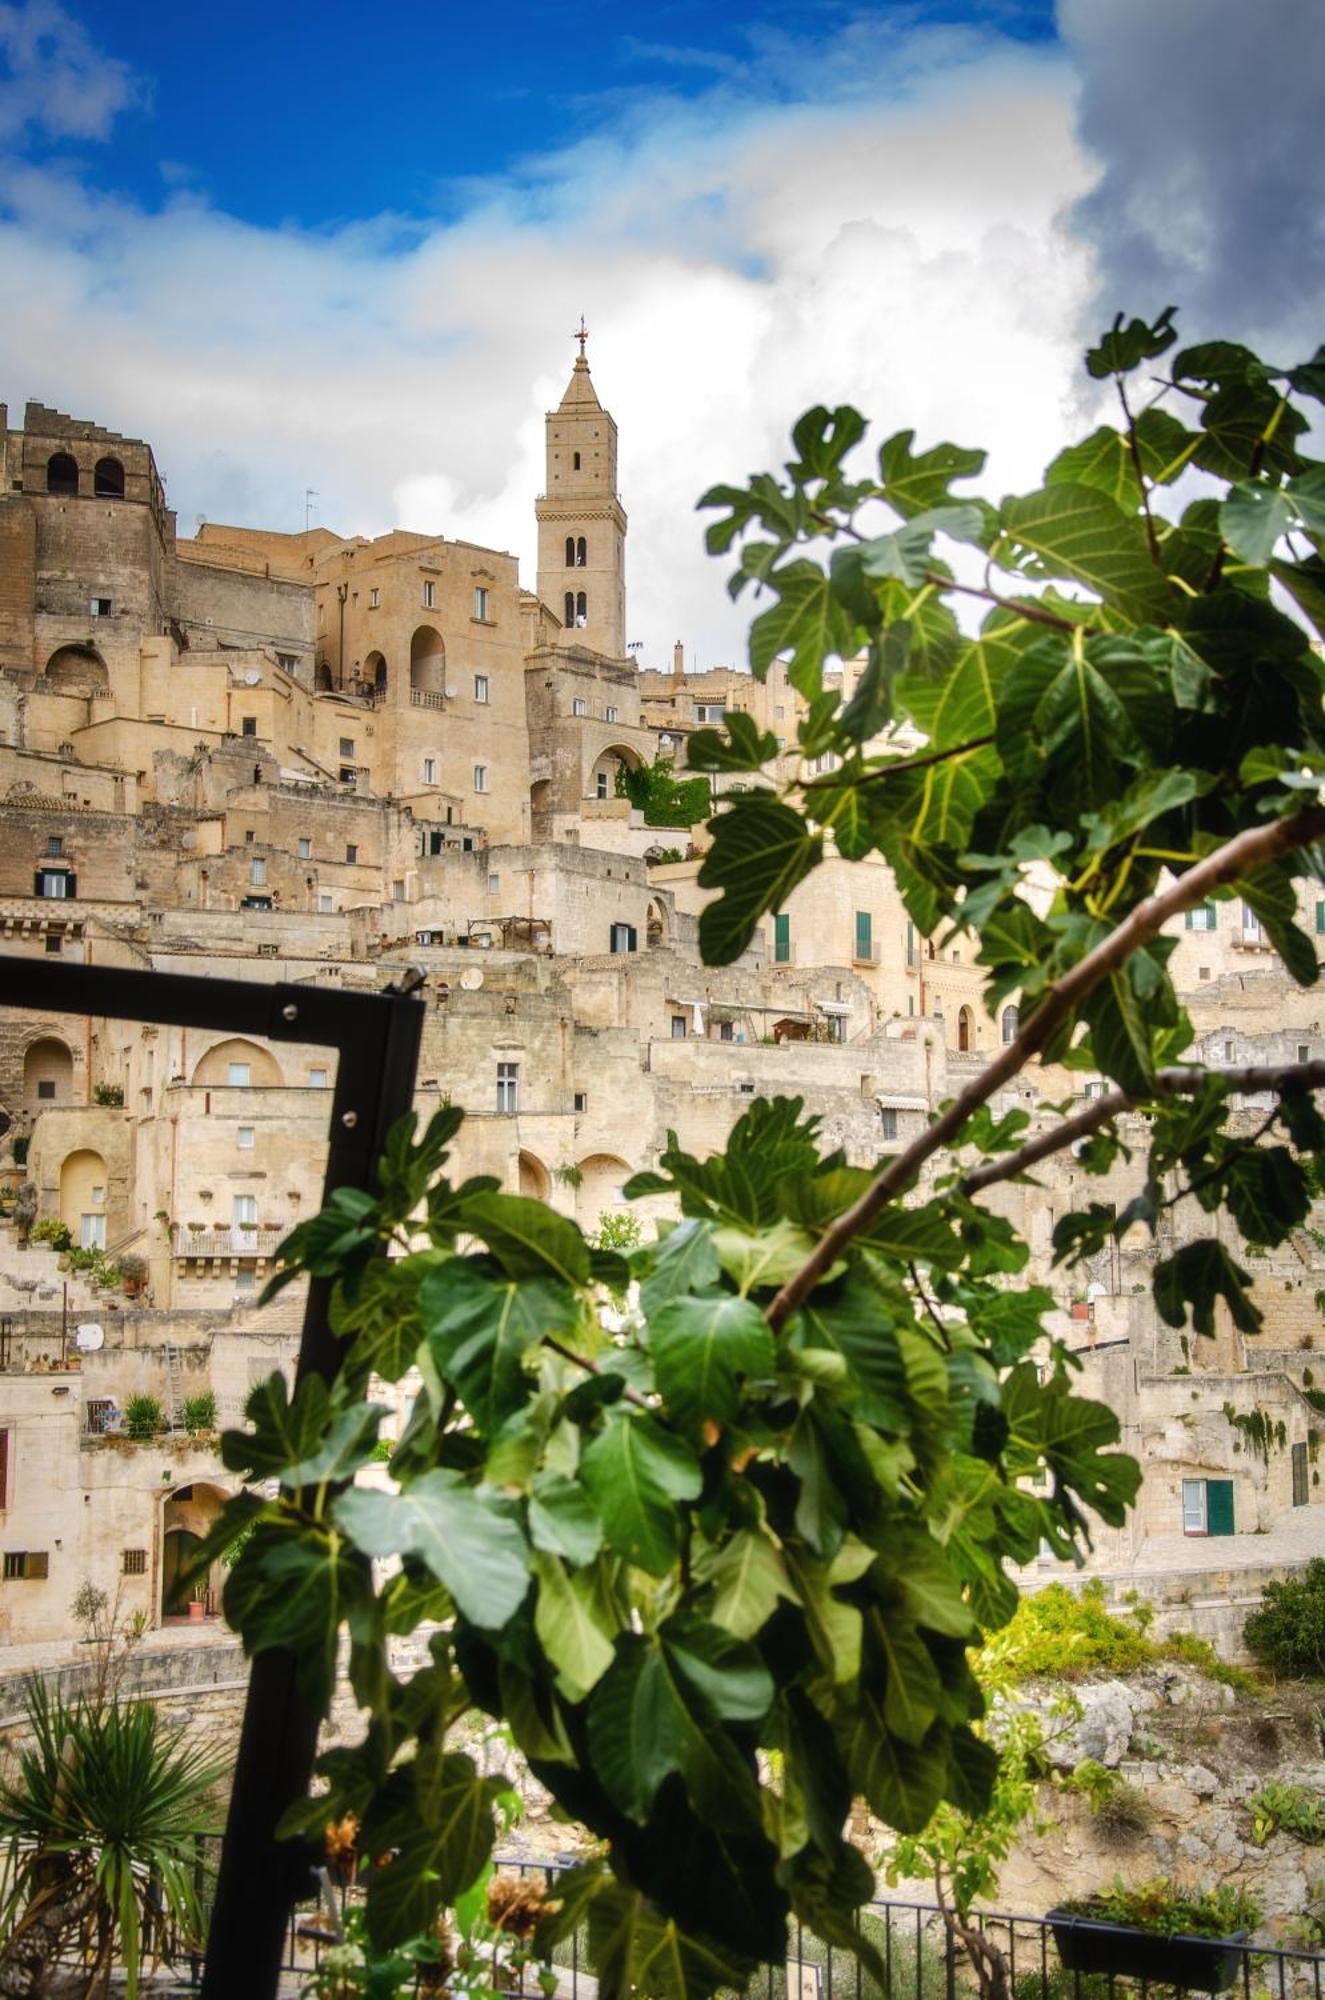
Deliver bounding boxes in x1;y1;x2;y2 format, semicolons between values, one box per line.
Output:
1045;1876;1261;1994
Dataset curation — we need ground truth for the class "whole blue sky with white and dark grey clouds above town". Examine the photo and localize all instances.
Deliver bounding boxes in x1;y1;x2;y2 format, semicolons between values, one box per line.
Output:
0;0;1325;664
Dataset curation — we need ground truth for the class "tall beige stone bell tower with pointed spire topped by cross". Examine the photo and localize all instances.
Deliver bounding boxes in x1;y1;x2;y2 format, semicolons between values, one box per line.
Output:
534;320;626;660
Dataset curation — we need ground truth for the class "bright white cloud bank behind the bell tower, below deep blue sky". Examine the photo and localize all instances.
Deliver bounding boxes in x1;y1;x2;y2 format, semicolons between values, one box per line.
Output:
0;4;1091;662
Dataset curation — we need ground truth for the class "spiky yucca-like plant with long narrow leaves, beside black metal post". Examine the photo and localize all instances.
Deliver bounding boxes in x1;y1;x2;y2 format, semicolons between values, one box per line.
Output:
0;1682;224;2000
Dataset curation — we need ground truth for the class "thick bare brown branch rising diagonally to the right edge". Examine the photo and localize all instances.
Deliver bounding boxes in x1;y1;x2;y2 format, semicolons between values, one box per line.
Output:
767;806;1325;1330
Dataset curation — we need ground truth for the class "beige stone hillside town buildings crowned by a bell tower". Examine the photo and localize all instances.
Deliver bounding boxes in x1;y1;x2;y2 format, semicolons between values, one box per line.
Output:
0;352;1325;1646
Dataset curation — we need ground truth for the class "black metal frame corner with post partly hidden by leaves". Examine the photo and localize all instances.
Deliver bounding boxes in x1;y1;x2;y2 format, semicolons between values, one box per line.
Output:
0;956;424;2000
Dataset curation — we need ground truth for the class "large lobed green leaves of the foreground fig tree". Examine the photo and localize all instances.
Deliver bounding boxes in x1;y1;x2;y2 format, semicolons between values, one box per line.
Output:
200;314;1325;2000
